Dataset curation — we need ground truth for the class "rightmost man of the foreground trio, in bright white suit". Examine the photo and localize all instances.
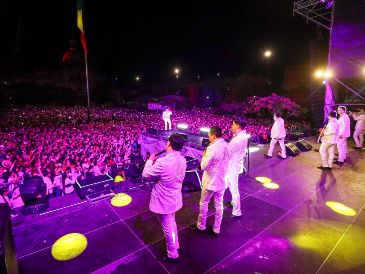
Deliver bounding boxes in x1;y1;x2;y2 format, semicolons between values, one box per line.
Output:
226;120;247;217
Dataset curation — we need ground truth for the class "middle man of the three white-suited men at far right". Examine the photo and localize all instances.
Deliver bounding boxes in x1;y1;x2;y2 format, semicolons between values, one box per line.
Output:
336;106;350;165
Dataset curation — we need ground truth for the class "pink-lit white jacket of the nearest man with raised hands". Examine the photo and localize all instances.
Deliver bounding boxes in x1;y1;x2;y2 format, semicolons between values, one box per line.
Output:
142;151;186;214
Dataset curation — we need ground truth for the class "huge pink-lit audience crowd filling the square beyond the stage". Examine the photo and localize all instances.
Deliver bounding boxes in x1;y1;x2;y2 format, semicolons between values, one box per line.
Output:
0;107;308;211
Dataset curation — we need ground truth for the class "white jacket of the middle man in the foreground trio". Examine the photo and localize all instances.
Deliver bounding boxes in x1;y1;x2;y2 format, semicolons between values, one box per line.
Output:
200;138;229;191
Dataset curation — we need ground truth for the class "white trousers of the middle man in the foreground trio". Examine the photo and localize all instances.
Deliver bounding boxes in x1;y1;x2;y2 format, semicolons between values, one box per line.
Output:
197;188;225;233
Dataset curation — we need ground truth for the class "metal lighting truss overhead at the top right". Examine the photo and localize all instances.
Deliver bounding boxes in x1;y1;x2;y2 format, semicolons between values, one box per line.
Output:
293;0;334;30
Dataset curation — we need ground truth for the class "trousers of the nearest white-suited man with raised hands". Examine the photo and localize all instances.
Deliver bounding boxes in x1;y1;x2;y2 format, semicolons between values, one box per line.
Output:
157;212;180;258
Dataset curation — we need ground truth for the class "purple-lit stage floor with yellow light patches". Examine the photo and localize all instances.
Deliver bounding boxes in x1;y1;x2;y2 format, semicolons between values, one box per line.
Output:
13;139;365;274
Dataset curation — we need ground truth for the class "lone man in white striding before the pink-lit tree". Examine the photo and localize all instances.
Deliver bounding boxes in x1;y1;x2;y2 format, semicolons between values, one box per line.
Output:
265;113;286;159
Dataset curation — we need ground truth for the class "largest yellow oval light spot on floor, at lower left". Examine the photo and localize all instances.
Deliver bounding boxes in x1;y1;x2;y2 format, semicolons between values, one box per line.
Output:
51;233;87;261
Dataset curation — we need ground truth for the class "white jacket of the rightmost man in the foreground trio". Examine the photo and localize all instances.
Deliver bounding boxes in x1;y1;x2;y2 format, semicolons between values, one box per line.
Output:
228;131;247;174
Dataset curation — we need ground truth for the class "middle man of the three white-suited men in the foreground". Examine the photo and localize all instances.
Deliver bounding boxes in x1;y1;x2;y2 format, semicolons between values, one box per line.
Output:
195;126;229;236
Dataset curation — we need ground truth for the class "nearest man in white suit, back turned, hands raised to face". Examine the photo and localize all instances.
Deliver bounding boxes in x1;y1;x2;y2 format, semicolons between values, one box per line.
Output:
142;134;186;261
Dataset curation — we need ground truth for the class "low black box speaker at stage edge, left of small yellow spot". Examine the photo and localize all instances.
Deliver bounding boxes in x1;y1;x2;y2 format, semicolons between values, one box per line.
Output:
75;174;114;198
